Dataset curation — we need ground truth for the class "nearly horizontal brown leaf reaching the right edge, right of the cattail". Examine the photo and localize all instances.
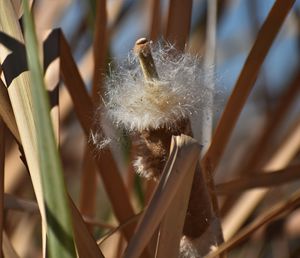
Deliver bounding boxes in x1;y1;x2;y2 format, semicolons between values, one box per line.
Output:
215;164;300;195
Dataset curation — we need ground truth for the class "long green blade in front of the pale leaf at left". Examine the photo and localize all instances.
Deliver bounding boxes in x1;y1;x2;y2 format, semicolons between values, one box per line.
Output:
23;0;76;258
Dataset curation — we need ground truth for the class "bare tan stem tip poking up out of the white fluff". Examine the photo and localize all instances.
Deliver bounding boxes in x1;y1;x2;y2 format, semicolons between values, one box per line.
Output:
134;38;159;82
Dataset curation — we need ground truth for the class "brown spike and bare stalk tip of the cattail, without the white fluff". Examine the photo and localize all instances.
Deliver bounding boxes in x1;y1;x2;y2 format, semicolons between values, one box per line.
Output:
133;38;223;255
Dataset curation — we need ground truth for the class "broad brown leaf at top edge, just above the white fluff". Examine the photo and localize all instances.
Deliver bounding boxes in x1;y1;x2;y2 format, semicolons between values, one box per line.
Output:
165;0;193;51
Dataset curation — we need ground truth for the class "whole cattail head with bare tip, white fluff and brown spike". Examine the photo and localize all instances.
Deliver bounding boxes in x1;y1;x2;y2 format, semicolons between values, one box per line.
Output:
95;38;222;255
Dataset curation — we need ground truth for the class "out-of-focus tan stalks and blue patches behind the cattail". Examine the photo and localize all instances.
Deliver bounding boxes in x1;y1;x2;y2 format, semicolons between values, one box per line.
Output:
0;0;300;257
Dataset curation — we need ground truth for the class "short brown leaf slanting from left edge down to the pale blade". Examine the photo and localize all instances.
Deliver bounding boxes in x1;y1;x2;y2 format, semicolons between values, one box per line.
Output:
0;79;21;143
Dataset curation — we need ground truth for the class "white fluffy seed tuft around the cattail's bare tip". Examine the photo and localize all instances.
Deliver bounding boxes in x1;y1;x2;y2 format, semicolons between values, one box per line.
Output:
104;44;216;131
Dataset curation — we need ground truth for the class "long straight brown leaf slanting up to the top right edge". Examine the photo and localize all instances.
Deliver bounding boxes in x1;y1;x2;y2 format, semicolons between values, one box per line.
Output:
202;0;295;174
